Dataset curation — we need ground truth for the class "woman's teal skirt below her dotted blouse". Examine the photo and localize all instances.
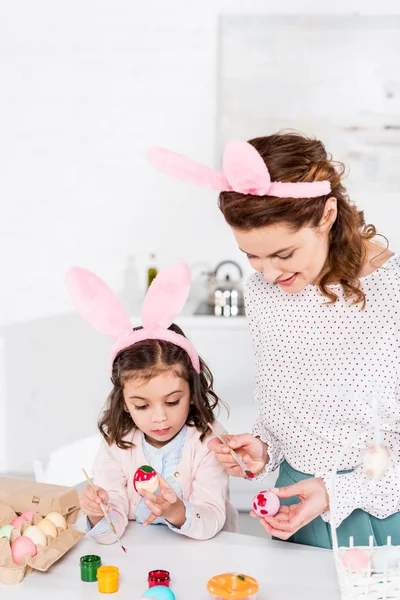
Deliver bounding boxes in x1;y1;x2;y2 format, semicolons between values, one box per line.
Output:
274;461;400;548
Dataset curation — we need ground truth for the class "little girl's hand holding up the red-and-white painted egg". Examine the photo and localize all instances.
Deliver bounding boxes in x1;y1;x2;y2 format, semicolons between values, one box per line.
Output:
141;474;186;528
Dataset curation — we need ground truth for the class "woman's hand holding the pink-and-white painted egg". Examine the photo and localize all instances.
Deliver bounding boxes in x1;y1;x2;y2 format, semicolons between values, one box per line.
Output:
250;477;329;540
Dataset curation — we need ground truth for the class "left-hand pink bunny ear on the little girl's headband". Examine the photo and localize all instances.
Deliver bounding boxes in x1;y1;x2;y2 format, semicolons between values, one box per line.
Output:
65;267;132;338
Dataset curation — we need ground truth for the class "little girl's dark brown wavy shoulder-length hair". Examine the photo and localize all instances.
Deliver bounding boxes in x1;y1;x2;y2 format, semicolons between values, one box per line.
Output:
98;324;222;449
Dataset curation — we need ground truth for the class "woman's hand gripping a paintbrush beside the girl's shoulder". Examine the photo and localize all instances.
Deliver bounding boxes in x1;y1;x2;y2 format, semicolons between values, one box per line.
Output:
208;433;269;477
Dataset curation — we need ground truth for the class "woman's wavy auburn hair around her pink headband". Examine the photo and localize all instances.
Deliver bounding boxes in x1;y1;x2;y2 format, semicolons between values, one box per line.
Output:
219;132;376;306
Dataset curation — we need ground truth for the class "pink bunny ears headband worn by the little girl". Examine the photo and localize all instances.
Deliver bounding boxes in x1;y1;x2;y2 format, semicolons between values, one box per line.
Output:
66;262;200;373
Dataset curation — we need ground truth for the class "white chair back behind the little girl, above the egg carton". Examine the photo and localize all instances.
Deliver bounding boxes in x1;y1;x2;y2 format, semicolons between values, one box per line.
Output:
33;434;102;487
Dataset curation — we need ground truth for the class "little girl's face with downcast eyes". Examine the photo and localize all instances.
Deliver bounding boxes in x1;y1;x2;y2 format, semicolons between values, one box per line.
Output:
123;371;190;448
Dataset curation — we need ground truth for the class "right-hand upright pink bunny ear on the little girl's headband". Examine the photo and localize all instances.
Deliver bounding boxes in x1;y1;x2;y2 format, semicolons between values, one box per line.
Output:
142;262;190;330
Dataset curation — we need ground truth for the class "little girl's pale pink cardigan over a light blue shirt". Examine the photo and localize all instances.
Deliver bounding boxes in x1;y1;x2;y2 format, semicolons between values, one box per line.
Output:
93;422;238;544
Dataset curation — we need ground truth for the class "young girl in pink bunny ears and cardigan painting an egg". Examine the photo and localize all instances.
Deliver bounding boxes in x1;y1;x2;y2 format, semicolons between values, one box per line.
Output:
67;263;237;544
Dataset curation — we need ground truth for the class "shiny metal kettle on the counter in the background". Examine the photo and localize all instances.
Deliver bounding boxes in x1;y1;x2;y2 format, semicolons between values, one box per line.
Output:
207;260;244;317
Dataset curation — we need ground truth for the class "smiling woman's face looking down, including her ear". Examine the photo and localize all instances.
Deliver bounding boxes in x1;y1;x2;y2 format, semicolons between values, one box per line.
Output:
232;198;336;294
